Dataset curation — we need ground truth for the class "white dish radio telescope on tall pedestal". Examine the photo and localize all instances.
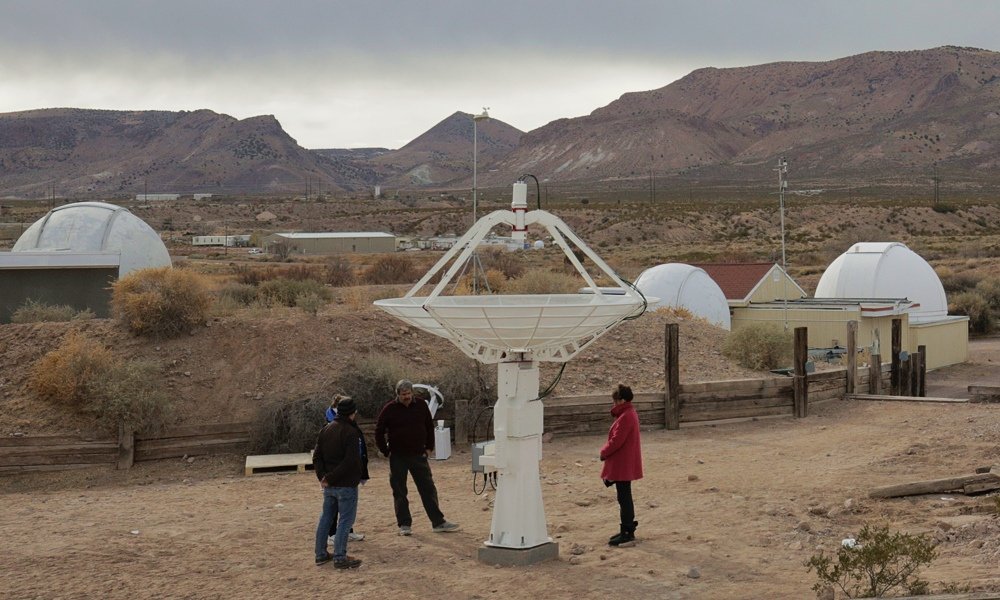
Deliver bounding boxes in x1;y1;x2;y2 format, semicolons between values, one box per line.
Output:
375;181;655;565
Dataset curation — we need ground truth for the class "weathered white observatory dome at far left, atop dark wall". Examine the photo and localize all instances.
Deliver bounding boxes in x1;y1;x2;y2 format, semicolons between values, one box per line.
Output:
11;202;170;277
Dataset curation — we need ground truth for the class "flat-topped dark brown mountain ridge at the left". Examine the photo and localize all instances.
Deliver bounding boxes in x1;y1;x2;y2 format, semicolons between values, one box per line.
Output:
0;108;363;197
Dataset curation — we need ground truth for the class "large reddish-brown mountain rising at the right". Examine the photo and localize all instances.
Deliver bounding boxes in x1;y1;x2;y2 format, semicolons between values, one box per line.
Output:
485;47;1000;184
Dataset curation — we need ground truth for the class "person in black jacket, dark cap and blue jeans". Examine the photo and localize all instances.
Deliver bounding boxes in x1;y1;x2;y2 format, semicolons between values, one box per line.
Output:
313;399;368;569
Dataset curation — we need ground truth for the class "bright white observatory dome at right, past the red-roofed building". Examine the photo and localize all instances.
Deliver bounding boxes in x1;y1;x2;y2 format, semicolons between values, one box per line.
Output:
816;242;948;321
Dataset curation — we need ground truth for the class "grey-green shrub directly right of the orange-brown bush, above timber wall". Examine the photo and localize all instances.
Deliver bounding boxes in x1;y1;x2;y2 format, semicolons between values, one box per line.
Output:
88;361;173;433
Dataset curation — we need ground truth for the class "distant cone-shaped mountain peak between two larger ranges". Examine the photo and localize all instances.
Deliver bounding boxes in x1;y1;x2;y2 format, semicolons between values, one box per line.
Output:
371;112;524;187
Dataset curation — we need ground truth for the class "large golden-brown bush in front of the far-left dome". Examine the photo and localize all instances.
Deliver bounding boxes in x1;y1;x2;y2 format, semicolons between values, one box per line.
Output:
111;267;212;337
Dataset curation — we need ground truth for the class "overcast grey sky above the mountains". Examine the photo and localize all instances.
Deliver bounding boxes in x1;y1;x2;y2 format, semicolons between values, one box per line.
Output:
0;0;1000;148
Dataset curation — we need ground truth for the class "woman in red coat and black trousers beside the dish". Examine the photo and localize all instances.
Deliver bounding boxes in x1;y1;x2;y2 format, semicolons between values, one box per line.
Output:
601;384;642;546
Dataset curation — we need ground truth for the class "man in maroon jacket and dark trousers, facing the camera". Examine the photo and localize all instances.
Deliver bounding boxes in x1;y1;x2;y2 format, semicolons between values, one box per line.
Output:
375;379;459;535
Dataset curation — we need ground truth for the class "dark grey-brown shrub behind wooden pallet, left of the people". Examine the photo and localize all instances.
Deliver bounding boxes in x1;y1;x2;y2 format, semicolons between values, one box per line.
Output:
250;395;330;454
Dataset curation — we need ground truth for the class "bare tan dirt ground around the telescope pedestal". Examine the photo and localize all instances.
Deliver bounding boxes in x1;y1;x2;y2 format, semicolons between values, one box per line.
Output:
0;340;1000;599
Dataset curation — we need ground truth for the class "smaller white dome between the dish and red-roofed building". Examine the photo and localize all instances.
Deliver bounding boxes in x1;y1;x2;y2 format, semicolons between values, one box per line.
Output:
635;263;732;330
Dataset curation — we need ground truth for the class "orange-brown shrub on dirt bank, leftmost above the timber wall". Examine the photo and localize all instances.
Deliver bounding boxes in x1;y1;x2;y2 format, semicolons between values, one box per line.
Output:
28;333;115;409
